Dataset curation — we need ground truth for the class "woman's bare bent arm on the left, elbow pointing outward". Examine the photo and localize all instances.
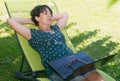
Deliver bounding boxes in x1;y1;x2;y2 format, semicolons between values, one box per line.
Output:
7;18;34;39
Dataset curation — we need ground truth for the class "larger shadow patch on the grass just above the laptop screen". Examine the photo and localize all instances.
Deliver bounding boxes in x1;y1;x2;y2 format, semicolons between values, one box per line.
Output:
81;36;118;59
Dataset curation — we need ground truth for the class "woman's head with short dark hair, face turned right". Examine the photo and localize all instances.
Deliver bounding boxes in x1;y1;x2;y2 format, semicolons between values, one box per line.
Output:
30;5;52;26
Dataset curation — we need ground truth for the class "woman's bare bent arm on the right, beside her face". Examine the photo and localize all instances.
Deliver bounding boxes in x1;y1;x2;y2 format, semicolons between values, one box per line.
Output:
52;13;68;30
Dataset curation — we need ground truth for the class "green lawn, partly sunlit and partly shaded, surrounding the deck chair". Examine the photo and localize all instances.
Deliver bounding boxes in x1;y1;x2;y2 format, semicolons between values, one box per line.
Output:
0;0;120;81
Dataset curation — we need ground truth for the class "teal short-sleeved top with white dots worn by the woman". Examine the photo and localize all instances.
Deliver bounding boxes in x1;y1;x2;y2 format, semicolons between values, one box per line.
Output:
28;25;73;76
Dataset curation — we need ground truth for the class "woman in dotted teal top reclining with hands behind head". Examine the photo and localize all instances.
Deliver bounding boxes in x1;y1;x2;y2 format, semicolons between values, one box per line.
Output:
7;5;104;81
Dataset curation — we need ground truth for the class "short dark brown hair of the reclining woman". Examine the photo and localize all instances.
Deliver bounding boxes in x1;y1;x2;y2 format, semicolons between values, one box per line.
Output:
30;5;52;26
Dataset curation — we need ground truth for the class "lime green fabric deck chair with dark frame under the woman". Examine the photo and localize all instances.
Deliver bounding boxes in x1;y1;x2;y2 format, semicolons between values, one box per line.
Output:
5;0;115;81
